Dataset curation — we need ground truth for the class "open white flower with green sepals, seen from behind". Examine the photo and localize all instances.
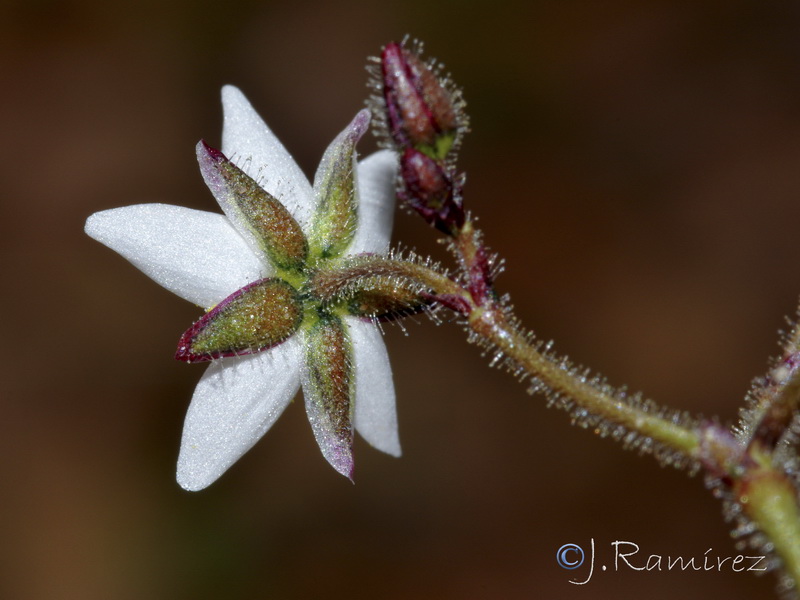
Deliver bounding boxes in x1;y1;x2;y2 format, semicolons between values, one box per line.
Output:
86;86;400;490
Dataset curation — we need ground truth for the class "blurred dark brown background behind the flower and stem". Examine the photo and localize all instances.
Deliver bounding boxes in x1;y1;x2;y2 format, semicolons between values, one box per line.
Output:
0;0;800;600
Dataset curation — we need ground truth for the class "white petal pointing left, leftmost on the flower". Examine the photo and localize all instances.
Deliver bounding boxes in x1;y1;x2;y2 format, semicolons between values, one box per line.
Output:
86;204;271;308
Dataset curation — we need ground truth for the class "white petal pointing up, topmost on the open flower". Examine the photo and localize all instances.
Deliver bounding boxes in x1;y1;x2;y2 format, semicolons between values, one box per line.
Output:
222;85;314;231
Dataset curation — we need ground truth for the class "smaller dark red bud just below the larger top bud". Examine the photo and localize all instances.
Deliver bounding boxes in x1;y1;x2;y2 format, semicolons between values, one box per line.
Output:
399;148;464;235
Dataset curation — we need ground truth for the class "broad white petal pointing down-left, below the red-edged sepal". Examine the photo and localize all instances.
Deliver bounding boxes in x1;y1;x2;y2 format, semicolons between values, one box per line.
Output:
178;336;301;491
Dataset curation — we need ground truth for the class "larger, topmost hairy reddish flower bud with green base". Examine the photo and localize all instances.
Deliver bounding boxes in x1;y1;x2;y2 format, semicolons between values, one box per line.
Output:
381;43;465;160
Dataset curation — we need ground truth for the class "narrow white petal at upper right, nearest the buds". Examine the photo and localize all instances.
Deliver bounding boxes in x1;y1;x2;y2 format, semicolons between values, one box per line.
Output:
348;150;398;254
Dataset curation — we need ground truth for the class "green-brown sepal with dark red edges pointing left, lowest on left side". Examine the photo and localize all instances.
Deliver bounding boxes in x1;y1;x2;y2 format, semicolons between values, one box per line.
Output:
175;278;303;363
